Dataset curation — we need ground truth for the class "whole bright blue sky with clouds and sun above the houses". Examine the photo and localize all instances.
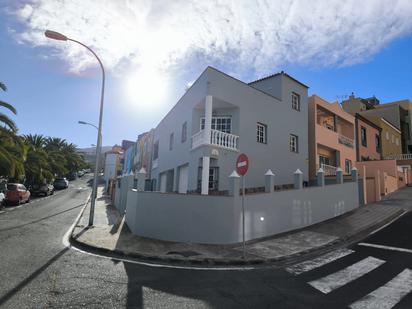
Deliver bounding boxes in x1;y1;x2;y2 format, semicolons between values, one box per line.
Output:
0;0;412;147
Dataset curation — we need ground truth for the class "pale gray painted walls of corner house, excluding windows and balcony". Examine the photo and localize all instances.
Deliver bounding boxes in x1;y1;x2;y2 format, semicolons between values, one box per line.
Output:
152;67;308;191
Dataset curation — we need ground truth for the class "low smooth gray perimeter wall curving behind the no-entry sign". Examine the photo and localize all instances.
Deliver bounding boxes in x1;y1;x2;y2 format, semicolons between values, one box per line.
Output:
126;182;359;244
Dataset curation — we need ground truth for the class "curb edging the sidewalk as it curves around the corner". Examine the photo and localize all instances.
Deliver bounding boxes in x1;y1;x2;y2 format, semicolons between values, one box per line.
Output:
69;205;407;268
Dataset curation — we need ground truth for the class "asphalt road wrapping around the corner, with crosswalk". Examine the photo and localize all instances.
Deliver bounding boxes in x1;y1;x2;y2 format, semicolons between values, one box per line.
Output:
0;180;412;308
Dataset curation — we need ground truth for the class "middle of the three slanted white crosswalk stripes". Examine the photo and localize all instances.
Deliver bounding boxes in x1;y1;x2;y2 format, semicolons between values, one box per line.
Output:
309;256;385;294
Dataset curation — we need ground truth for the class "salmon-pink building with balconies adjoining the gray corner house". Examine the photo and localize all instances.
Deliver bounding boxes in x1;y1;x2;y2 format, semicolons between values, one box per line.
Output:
308;95;356;180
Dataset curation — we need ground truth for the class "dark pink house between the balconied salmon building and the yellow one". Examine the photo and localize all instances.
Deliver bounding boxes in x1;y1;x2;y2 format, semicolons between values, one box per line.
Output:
355;114;382;162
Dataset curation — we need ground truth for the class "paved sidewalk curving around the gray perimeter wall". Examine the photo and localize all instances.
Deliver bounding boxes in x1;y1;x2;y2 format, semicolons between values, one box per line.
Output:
71;187;406;266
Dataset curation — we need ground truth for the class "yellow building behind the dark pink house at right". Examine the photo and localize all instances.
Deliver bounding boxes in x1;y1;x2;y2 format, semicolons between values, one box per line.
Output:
361;113;402;158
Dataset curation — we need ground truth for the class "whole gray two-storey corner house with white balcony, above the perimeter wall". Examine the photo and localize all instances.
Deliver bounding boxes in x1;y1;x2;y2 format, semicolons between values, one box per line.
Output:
151;67;308;195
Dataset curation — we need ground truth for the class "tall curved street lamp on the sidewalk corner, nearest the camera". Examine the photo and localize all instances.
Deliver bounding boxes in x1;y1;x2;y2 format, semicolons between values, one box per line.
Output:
44;30;105;226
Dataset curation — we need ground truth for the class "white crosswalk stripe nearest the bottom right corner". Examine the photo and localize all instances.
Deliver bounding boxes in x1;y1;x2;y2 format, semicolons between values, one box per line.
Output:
350;268;412;309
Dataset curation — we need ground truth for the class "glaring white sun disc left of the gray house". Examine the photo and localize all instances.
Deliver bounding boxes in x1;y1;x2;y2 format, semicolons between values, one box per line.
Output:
125;69;168;111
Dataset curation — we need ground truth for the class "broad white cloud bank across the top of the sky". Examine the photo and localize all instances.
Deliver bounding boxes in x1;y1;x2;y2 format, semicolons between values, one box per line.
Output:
7;0;412;75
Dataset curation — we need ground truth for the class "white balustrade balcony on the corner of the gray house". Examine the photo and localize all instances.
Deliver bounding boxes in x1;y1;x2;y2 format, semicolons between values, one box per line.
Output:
192;130;239;151
